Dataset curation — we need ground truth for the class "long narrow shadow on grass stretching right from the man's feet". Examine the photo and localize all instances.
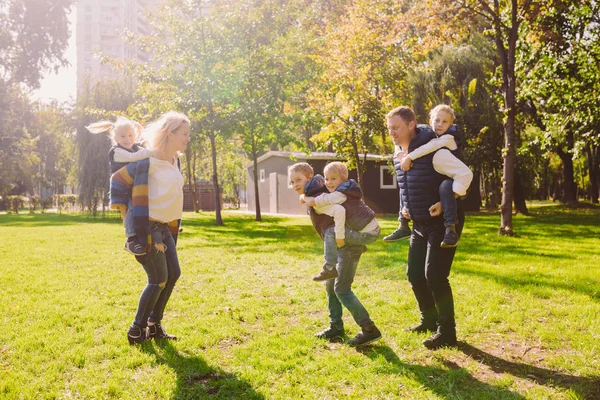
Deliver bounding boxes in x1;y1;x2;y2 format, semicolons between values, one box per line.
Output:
458;342;600;399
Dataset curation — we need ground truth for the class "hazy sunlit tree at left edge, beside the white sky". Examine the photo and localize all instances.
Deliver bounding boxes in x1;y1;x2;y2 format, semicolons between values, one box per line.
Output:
0;0;72;200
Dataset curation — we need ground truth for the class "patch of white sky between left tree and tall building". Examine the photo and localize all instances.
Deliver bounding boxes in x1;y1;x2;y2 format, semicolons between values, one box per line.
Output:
31;6;77;103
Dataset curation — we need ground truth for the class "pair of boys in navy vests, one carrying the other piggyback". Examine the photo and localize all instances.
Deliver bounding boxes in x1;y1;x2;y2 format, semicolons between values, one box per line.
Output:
290;163;381;346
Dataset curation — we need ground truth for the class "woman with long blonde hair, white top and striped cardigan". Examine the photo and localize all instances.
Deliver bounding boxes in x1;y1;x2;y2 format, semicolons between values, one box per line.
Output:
111;112;190;344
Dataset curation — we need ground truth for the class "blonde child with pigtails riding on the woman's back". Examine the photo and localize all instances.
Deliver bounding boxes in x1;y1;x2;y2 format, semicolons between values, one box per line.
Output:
86;116;156;256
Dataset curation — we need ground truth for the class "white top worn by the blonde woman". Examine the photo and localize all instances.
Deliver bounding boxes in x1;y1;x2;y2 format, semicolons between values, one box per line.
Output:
148;157;183;222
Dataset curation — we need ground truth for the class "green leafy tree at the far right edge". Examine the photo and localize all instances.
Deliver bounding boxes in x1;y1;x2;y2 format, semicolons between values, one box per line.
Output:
518;0;600;205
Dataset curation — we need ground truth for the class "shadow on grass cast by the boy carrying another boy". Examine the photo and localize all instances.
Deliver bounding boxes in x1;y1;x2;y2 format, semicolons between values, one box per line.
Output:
357;345;525;400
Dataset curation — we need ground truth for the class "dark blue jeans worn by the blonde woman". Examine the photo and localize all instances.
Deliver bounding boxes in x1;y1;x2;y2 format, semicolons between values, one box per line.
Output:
133;222;181;328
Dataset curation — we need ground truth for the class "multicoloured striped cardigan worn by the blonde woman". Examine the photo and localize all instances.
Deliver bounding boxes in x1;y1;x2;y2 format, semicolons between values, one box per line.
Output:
110;158;180;251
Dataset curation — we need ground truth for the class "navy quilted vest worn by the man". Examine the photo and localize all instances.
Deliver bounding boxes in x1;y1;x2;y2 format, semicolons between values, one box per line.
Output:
394;125;446;222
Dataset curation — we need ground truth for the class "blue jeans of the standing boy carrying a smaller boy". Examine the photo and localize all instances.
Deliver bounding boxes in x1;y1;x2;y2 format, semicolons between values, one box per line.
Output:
325;245;375;329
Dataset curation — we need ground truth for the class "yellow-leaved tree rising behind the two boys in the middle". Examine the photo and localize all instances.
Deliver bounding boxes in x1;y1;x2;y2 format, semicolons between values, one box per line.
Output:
311;0;409;183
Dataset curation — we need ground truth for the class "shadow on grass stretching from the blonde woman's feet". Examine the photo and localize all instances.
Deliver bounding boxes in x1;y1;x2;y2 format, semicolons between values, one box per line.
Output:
141;341;264;400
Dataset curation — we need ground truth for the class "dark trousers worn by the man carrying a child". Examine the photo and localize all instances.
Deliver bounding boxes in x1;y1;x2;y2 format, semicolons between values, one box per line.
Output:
406;217;462;332
